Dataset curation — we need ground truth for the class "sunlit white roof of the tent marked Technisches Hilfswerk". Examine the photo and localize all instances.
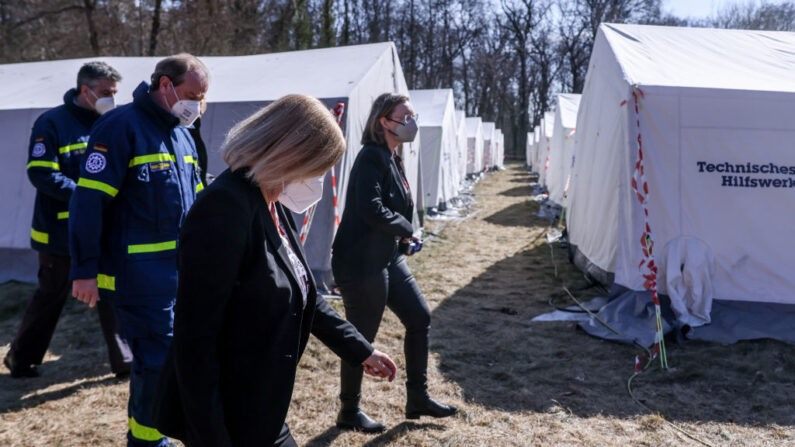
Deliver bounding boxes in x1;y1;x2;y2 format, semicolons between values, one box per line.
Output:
600;23;795;92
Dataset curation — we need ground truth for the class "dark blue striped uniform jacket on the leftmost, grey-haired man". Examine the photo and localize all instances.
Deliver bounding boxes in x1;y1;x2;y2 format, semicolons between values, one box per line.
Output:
27;89;99;255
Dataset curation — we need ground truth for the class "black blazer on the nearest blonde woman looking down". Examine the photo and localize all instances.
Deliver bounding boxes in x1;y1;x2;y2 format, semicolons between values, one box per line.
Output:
153;170;373;447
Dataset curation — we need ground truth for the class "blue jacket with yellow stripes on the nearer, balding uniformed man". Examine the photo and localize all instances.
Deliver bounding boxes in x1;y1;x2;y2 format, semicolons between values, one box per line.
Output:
69;82;202;304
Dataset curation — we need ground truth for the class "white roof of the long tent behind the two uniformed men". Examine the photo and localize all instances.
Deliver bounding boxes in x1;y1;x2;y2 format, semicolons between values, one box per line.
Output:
0;42;393;109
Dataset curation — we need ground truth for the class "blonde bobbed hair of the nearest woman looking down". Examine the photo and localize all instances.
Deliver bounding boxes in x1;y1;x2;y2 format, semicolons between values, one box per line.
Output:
221;95;345;196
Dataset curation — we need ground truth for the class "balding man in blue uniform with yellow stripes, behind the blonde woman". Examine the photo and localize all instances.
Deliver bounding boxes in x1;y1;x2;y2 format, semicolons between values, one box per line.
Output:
69;54;209;446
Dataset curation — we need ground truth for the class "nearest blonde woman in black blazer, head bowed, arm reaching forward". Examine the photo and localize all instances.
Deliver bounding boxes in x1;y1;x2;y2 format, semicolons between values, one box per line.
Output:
154;95;395;447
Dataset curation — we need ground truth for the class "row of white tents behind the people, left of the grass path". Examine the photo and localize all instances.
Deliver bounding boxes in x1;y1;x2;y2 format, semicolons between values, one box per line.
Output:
0;43;502;286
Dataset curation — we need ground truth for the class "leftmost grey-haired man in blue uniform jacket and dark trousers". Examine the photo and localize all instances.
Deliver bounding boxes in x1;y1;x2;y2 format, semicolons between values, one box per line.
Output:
4;62;132;377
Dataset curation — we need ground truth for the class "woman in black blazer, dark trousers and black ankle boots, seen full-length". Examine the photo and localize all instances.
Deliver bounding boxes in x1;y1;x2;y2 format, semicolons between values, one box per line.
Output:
331;93;458;433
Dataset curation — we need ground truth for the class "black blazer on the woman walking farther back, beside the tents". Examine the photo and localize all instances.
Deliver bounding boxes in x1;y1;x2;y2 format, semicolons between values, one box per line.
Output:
331;145;414;283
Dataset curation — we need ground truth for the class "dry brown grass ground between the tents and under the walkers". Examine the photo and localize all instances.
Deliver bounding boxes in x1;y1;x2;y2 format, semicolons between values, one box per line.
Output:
0;167;795;447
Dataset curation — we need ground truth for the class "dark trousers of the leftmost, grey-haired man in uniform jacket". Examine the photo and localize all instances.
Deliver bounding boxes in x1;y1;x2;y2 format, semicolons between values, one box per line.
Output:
8;252;132;373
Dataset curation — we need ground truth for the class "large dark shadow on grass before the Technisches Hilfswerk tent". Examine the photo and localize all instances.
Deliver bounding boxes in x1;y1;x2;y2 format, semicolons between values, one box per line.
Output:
431;245;795;426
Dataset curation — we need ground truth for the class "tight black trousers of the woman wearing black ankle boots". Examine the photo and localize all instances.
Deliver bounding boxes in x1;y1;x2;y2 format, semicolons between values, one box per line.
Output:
337;255;431;401
